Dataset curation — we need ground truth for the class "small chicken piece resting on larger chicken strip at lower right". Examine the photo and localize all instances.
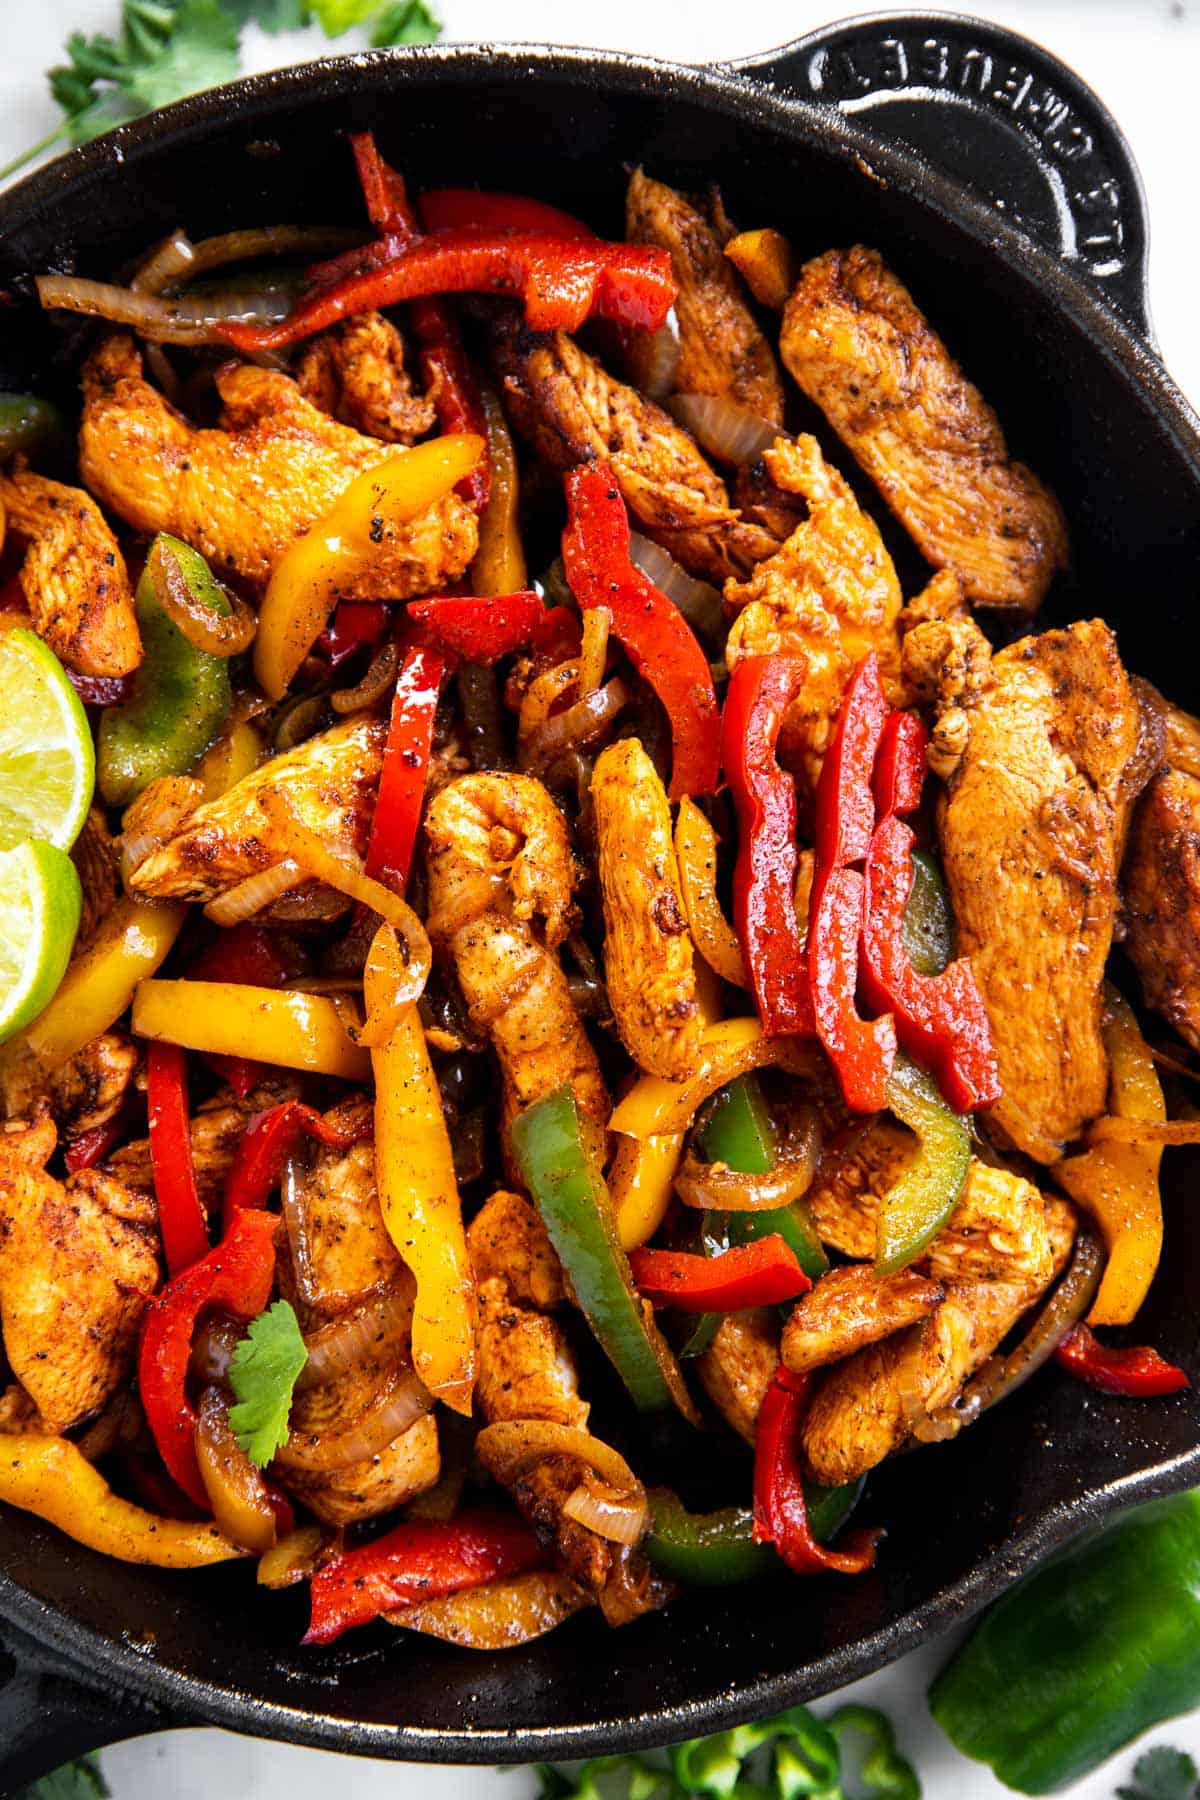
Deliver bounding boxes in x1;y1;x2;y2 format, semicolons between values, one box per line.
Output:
779;1264;946;1375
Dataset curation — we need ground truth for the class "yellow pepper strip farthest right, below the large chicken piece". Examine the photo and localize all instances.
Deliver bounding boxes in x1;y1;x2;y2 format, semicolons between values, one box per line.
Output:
1054;988;1166;1325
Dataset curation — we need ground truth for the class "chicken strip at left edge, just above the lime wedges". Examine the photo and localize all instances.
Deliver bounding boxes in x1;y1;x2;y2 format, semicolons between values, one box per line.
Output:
0;470;142;675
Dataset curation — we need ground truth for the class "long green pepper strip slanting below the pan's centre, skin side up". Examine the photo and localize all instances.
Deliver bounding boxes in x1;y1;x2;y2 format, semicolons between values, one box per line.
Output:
511;1084;696;1420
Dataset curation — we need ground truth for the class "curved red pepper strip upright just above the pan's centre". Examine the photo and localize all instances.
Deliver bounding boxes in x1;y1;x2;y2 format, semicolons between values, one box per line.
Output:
563;463;721;799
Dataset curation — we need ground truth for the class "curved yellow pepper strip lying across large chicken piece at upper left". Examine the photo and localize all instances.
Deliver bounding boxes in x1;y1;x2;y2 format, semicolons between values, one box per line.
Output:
254;432;486;700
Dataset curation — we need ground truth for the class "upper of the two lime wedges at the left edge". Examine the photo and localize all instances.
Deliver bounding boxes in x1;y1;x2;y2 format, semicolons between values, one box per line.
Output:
0;625;95;850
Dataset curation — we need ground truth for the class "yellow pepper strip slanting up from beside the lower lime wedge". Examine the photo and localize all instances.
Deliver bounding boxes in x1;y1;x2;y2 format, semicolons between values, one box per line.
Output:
9;896;187;1069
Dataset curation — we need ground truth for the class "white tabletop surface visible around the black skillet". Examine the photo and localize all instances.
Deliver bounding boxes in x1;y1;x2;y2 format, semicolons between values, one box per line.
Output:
0;0;1200;1800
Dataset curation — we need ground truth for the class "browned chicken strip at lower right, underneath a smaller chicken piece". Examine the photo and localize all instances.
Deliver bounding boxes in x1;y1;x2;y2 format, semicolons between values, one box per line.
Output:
801;1197;1076;1487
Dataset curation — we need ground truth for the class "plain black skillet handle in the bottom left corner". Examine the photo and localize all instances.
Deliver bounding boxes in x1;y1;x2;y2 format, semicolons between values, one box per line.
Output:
0;1624;200;1800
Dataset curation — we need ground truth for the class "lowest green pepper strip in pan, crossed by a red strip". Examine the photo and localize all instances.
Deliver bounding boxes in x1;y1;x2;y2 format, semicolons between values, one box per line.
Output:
642;1480;864;1588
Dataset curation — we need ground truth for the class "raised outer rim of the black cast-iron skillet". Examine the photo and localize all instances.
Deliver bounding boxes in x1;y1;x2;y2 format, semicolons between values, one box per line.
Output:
0;35;1200;1762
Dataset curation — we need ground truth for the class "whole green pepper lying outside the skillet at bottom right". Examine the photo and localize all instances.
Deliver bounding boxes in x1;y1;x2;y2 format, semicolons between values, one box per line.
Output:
930;1489;1200;1795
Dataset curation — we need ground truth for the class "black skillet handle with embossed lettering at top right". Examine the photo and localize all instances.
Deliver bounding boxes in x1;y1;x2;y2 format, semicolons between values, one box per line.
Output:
732;13;1153;347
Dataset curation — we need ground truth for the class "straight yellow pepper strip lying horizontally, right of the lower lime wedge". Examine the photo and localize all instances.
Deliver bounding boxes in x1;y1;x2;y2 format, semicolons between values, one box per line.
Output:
133;981;371;1082
